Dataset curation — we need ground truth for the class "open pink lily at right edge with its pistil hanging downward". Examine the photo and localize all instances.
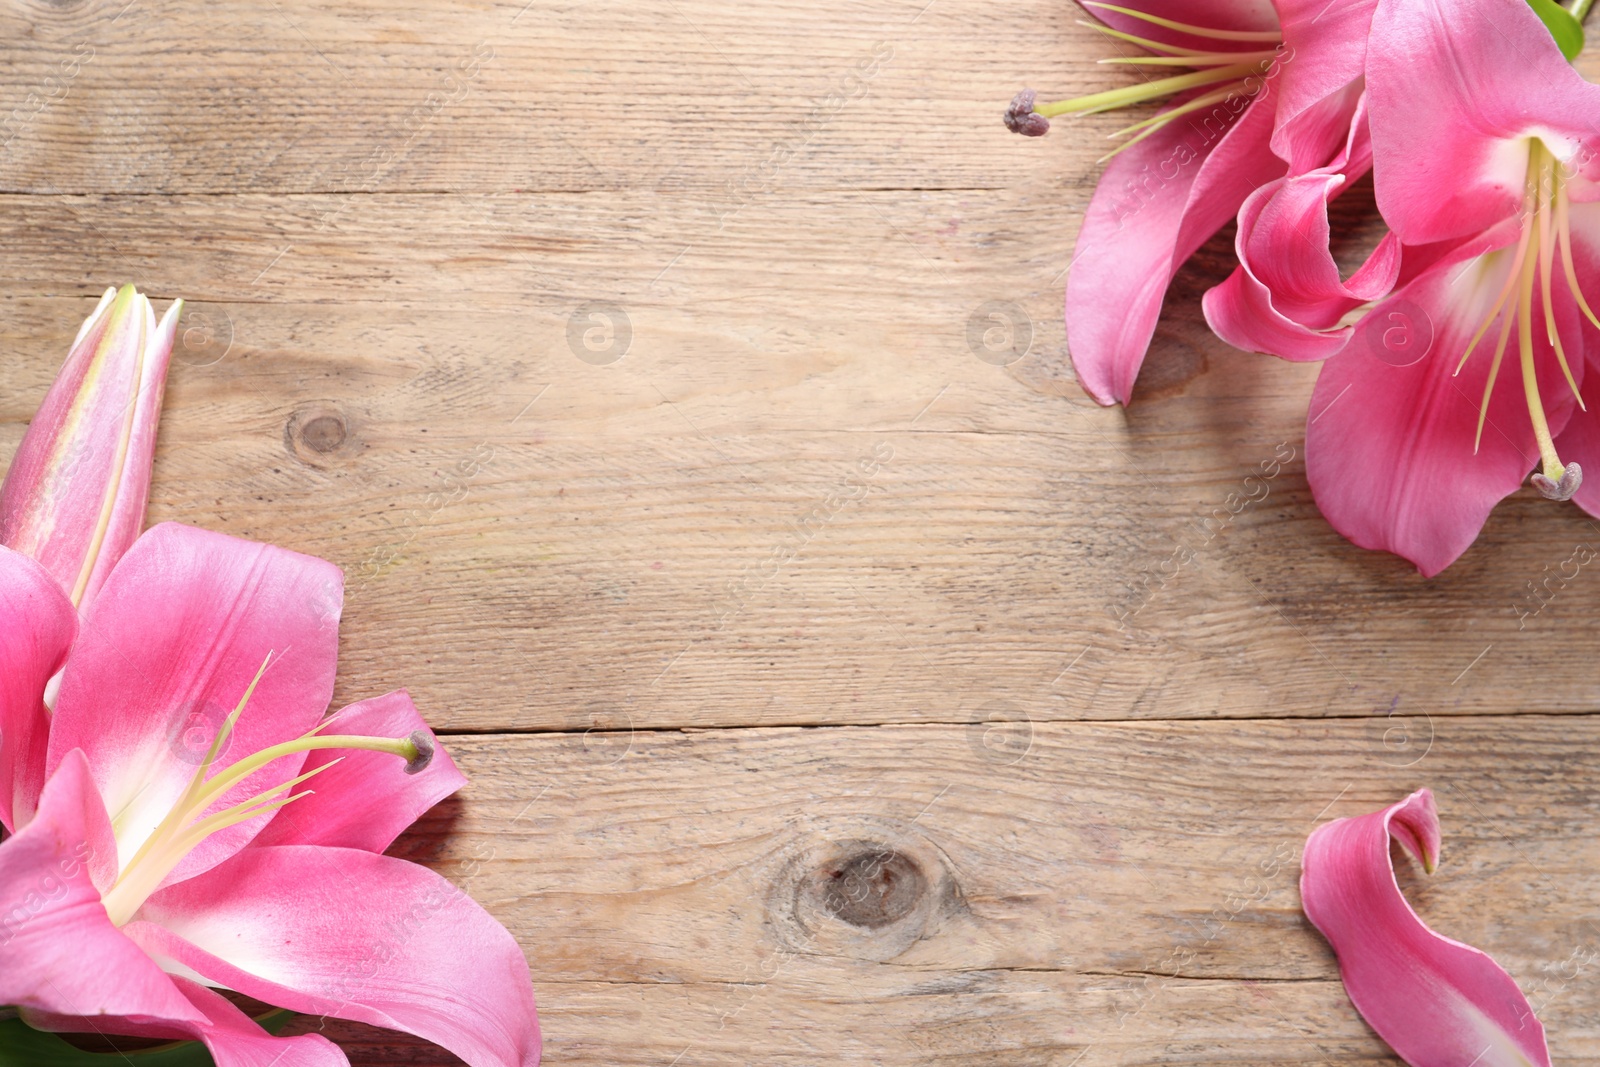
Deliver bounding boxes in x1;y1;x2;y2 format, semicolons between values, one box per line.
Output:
1306;0;1600;576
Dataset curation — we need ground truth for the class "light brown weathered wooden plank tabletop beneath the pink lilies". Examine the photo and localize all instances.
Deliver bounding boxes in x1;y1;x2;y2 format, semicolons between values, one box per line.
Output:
0;0;1600;1067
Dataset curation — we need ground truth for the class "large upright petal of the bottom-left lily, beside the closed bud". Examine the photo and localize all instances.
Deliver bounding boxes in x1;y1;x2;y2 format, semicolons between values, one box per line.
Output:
50;523;342;880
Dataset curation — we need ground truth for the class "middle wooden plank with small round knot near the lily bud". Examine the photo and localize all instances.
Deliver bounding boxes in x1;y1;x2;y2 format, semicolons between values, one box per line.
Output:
0;194;1600;729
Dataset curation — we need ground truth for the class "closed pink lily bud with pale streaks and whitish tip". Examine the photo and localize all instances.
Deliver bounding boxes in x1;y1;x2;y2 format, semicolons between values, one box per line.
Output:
0;285;184;609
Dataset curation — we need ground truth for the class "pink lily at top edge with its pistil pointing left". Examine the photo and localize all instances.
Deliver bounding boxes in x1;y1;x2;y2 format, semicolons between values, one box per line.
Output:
1006;0;1374;405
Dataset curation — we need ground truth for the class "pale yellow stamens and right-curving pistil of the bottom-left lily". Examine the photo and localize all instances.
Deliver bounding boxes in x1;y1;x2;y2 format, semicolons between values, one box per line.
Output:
104;656;434;926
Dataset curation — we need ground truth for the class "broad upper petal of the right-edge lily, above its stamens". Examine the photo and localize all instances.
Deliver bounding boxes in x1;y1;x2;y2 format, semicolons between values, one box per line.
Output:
1366;0;1600;245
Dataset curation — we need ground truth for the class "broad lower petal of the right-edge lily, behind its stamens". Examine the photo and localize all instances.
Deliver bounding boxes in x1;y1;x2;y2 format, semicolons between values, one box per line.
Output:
1306;227;1582;576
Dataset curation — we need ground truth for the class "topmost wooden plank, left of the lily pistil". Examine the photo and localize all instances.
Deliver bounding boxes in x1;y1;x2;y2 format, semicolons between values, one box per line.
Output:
0;0;1113;195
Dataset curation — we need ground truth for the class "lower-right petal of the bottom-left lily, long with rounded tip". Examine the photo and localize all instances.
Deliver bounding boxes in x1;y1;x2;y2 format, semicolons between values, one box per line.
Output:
125;845;539;1067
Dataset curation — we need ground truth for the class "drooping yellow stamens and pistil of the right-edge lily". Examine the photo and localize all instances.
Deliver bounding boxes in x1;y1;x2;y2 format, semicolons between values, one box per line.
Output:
1456;138;1600;501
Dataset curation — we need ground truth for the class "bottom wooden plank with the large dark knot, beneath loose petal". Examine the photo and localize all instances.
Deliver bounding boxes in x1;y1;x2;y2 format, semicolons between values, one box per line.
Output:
281;715;1600;1067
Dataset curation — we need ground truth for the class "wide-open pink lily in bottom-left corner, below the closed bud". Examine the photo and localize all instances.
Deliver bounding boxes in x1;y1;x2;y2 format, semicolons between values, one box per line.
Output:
0;523;539;1067
